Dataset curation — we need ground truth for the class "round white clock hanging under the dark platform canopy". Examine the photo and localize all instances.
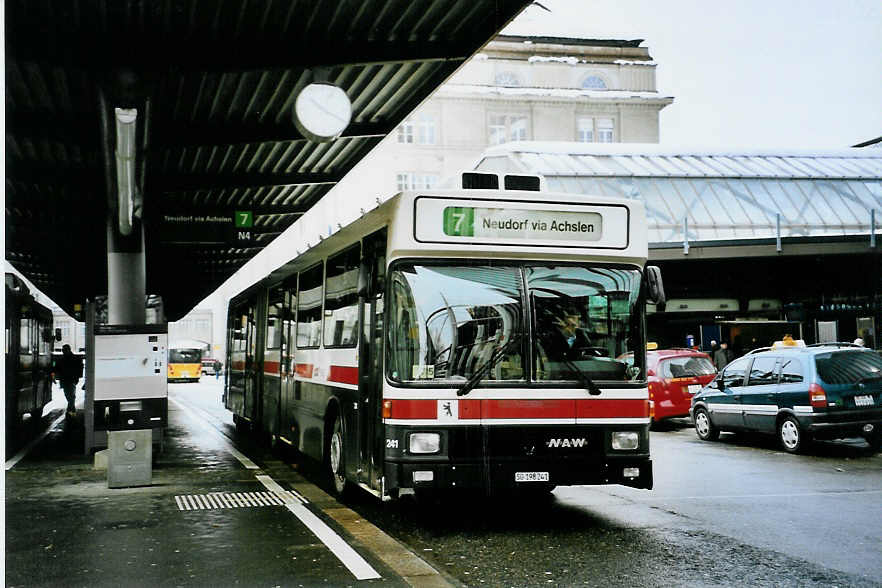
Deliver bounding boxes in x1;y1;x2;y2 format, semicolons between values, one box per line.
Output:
294;84;352;143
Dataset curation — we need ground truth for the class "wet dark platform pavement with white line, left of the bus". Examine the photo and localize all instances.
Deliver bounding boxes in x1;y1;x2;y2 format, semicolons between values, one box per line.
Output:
5;382;455;587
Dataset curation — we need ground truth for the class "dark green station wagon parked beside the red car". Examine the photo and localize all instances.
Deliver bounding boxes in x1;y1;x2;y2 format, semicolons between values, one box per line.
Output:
689;345;882;453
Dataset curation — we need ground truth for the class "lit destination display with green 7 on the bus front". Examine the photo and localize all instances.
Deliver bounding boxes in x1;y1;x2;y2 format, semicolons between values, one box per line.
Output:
443;206;603;241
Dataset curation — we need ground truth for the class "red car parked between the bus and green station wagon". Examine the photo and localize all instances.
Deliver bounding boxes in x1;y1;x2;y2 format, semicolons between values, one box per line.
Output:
624;349;717;421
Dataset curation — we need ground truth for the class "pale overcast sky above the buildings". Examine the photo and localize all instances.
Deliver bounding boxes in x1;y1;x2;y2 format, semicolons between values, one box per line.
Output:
503;0;882;149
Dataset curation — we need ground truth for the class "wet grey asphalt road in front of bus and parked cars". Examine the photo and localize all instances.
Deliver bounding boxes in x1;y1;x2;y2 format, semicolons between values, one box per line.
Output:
180;384;882;587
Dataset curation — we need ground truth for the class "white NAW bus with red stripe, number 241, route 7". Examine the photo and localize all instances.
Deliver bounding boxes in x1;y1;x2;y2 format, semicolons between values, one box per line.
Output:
224;174;664;499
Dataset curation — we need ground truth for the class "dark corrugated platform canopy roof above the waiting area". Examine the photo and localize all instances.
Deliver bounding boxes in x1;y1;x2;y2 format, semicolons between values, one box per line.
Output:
5;0;530;320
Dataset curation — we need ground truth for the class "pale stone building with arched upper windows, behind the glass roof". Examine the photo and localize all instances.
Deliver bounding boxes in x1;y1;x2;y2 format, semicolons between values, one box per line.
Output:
357;36;673;195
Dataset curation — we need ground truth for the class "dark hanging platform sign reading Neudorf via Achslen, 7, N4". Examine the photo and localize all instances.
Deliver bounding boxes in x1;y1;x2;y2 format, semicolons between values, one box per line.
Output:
159;210;254;246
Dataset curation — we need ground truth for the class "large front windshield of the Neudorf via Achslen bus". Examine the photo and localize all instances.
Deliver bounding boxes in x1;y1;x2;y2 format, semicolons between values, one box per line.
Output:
386;263;643;386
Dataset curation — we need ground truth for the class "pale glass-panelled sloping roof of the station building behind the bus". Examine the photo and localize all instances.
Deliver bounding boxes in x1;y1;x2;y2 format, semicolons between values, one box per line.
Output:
476;141;882;246
